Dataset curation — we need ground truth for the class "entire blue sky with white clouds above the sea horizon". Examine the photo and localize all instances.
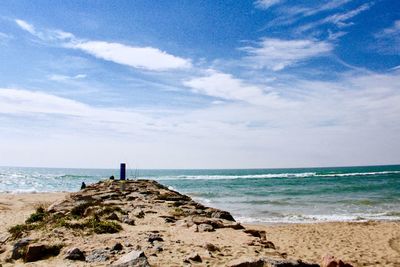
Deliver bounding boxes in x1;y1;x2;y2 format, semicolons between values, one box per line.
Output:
0;0;400;168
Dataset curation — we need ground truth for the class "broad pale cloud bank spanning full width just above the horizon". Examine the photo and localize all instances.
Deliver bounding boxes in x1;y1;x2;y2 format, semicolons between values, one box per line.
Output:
0;71;400;168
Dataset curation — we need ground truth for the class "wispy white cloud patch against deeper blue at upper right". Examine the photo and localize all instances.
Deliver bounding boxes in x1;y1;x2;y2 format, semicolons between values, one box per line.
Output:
240;38;333;71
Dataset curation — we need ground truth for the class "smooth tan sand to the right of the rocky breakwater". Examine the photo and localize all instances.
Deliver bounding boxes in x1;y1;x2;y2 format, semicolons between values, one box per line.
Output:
252;221;400;266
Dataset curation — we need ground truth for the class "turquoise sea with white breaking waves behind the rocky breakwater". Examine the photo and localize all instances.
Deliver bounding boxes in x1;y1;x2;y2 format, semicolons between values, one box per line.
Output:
0;165;400;223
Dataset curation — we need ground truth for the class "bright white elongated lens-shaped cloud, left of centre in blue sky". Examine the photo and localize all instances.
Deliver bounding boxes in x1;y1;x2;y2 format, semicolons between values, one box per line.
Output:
70;41;191;71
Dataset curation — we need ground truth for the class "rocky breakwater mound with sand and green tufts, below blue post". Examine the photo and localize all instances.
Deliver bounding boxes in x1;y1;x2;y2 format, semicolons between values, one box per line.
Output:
0;180;348;267
